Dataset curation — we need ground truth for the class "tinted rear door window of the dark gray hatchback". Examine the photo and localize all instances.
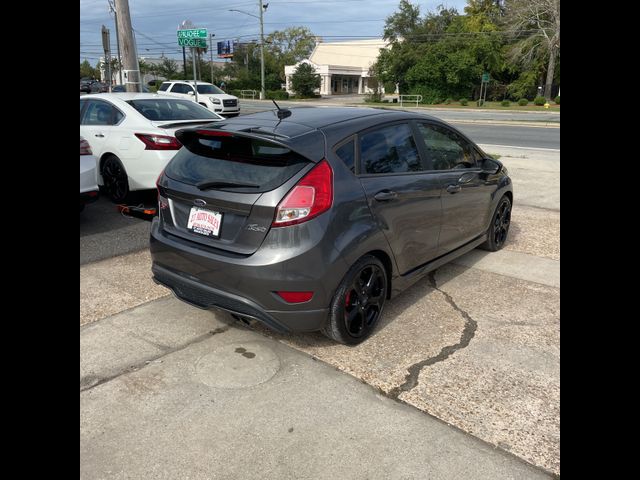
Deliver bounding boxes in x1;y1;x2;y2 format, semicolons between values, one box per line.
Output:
360;123;423;173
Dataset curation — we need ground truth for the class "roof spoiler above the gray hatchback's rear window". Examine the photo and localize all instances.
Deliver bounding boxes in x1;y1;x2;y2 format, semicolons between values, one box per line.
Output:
176;126;326;163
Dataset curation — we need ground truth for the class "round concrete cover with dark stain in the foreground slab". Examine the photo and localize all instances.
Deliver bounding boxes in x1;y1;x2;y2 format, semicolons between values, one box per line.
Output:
196;342;280;388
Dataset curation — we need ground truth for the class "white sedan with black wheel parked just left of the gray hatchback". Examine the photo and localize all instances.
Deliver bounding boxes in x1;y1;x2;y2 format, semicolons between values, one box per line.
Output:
80;93;224;203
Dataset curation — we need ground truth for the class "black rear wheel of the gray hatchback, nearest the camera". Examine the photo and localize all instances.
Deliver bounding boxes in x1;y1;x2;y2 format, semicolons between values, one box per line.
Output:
322;255;389;345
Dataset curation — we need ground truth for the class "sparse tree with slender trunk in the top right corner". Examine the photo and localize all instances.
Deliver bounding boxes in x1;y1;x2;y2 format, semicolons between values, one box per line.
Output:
506;0;560;100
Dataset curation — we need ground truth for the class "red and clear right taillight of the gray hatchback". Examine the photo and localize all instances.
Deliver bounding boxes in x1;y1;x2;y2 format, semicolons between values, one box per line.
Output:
271;160;333;227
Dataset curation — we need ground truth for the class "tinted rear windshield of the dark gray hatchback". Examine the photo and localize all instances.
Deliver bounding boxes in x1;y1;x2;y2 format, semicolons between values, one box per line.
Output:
165;132;309;192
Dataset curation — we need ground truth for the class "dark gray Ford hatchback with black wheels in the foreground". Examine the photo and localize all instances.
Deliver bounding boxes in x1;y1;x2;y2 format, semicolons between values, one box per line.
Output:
150;107;513;344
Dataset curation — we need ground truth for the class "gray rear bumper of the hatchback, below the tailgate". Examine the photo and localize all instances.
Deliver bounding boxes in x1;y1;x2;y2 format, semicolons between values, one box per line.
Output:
150;218;346;332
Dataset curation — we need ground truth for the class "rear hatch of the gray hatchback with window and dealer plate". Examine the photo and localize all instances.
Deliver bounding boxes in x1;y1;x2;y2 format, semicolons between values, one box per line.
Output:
158;129;314;255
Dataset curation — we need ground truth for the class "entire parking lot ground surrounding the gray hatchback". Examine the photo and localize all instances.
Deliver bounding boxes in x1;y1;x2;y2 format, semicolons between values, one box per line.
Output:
80;108;560;479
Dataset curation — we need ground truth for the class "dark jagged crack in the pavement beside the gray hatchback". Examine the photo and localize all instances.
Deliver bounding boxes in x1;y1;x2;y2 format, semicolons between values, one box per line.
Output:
388;271;478;399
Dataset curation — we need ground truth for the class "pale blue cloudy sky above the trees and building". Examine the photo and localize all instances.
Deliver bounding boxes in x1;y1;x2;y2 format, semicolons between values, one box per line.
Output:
80;0;467;66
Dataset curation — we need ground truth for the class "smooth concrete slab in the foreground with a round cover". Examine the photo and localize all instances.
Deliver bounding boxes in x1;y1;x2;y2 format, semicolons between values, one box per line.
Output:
80;298;549;480
